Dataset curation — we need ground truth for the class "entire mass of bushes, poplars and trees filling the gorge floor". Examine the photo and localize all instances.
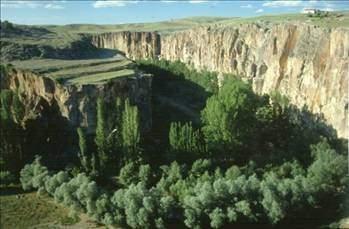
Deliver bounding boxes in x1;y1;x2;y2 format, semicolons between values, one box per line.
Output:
1;60;349;228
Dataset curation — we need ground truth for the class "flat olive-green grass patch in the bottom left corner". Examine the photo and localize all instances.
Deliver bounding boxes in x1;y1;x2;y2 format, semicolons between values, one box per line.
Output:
0;188;78;229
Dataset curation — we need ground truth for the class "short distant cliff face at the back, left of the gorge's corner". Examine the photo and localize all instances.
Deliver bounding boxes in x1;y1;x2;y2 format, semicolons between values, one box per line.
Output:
91;32;161;60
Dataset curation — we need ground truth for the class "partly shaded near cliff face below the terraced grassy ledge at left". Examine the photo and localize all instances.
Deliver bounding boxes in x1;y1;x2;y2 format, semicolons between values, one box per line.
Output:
1;69;151;133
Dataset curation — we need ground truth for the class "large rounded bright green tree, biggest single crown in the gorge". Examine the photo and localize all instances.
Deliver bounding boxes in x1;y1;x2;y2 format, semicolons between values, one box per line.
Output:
202;79;258;156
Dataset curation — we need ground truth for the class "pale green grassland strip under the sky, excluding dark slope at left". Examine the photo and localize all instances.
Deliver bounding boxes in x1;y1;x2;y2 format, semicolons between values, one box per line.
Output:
1;11;349;50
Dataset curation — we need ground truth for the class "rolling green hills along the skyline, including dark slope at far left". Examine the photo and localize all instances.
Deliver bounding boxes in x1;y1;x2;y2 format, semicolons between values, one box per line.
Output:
0;11;349;61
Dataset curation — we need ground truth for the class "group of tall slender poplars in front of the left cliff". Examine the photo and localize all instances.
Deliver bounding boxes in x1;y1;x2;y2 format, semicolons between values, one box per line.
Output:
77;98;141;177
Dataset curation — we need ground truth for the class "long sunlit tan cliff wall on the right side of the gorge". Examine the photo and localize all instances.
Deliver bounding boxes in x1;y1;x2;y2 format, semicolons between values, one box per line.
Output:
161;24;349;138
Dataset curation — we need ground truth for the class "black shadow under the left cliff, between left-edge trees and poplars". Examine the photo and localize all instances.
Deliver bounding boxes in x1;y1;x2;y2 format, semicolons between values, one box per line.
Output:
24;98;78;169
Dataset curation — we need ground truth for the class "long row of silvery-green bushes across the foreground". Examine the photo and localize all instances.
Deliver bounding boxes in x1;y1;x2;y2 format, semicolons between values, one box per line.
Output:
20;141;348;228
